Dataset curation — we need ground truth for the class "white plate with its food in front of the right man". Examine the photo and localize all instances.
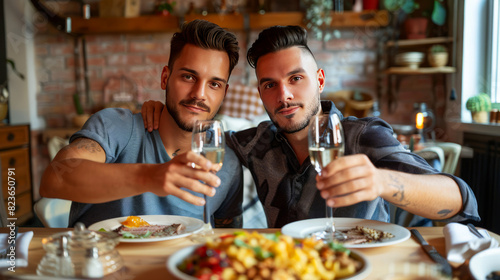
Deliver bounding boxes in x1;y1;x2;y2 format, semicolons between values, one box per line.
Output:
281;218;411;248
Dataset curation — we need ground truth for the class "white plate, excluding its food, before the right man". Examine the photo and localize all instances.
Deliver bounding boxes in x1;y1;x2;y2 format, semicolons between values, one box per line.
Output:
281;218;411;248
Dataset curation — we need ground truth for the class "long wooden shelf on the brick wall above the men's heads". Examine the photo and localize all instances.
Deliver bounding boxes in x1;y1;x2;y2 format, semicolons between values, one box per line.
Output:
68;10;389;34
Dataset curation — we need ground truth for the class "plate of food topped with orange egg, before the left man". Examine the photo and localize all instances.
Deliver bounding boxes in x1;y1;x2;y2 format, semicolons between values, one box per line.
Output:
89;215;203;242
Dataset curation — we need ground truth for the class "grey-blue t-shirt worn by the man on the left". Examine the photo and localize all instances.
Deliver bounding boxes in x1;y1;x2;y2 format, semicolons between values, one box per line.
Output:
69;108;243;227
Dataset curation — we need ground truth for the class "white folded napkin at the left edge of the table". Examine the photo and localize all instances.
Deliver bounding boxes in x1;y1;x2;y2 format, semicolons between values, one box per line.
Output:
0;231;33;269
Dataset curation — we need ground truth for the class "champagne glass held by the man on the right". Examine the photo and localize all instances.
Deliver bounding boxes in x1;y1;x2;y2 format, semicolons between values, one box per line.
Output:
308;114;345;239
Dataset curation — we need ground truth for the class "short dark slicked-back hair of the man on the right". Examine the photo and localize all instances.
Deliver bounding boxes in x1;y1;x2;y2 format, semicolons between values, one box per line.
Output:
247;25;314;68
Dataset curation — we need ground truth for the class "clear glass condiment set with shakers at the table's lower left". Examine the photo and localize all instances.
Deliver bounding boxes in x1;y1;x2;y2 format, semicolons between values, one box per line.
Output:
36;223;123;278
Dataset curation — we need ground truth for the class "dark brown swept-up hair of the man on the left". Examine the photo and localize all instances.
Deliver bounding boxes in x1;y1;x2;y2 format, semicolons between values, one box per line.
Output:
168;19;240;76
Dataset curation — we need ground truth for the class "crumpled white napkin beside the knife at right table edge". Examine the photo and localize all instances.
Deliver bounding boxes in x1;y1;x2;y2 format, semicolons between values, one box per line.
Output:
443;223;498;263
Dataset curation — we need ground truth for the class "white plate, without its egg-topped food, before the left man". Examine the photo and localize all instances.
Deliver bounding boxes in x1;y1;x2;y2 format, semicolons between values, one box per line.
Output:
89;215;203;243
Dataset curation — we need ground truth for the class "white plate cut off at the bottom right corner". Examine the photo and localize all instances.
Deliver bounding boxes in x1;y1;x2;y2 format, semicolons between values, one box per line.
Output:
469;248;500;280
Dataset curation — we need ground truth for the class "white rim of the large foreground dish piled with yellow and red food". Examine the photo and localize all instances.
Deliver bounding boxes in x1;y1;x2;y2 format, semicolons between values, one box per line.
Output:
167;245;372;280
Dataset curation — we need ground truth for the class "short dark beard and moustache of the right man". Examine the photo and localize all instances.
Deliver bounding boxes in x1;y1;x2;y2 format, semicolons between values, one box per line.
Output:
266;94;320;134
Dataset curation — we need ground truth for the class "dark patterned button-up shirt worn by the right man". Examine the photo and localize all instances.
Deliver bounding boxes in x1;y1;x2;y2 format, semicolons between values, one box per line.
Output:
227;101;479;227
